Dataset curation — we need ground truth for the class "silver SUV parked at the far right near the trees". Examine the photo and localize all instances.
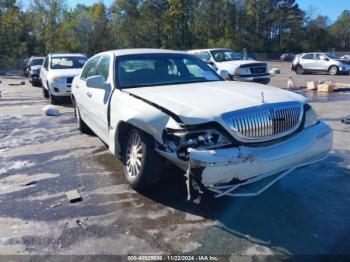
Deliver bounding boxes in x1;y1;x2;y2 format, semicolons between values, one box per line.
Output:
292;53;350;75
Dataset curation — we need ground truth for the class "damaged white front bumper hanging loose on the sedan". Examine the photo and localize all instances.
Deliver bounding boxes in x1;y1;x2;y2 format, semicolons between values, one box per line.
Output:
160;122;333;194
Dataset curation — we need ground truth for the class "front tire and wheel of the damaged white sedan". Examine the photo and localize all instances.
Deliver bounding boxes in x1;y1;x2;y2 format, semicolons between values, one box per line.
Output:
123;129;162;190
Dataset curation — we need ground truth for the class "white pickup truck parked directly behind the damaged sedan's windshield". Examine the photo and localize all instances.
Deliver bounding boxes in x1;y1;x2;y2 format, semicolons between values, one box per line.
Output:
188;48;271;84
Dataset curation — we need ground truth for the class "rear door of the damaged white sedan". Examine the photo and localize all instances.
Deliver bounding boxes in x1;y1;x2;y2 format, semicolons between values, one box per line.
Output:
74;56;101;131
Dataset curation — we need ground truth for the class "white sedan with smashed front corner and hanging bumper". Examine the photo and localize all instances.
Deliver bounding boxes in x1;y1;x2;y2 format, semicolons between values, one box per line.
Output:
72;49;332;198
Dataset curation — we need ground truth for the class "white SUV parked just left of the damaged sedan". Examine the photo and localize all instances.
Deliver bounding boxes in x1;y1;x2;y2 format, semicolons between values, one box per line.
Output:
40;54;87;104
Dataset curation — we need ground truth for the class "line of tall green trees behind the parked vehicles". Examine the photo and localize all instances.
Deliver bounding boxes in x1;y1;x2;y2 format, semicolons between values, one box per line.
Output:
0;0;350;57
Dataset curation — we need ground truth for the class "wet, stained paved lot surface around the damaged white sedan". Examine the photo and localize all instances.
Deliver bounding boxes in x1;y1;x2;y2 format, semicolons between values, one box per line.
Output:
0;63;350;258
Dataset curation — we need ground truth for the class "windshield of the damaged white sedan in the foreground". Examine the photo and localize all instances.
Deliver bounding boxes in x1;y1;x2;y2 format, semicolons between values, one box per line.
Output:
115;54;223;88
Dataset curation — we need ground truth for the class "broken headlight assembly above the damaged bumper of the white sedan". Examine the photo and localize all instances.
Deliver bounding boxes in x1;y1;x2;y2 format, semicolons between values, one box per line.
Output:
163;125;232;160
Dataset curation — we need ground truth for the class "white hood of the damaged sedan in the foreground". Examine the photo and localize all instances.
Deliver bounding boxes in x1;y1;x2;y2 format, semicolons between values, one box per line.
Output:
124;81;307;124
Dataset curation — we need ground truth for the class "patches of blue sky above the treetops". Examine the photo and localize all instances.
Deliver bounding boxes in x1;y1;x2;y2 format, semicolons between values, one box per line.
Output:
21;0;350;21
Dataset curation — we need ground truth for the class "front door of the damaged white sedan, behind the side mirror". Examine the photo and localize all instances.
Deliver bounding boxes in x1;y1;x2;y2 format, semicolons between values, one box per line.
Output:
87;55;113;142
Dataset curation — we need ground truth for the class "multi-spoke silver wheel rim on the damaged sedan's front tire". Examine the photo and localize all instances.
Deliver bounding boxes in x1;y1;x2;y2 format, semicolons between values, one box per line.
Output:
126;133;143;180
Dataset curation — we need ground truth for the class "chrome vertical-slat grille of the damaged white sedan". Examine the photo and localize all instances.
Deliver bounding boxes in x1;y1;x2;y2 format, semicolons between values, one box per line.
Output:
223;102;303;142
